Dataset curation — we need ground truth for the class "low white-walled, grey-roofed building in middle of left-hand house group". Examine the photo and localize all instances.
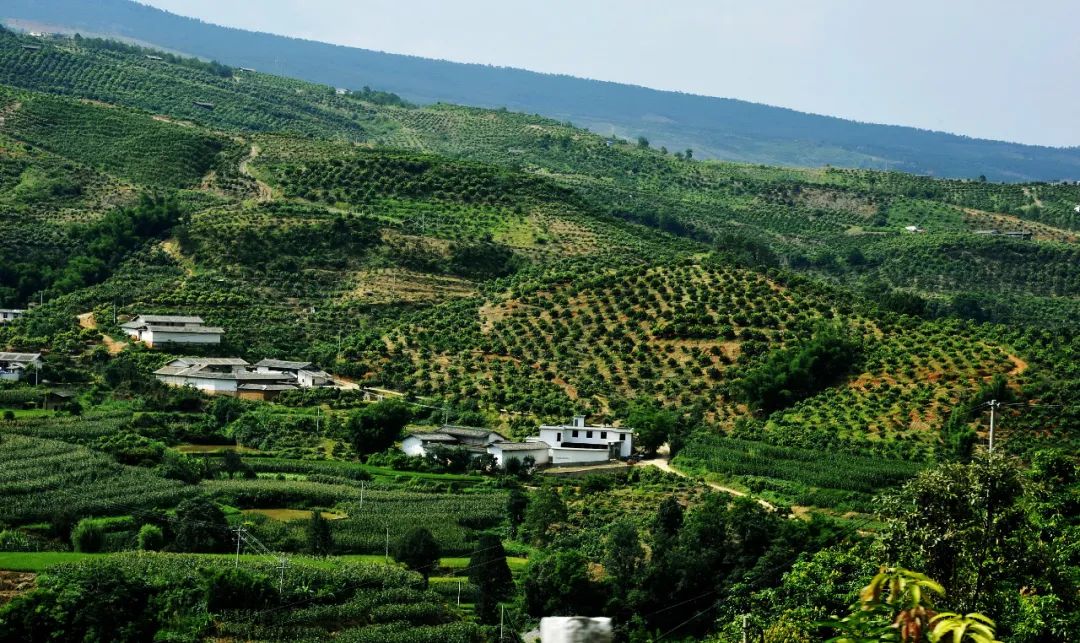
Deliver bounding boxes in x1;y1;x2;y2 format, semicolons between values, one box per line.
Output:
153;358;296;398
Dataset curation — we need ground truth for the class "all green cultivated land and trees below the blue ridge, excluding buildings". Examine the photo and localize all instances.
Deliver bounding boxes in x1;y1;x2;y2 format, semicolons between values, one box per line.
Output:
0;30;1080;643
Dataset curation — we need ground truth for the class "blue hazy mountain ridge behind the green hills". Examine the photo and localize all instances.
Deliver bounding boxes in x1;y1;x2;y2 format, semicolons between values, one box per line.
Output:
8;0;1080;182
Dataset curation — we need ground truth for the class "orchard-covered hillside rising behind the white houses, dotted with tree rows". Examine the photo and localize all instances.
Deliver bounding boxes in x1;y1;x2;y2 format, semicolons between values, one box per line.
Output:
0;26;1080;484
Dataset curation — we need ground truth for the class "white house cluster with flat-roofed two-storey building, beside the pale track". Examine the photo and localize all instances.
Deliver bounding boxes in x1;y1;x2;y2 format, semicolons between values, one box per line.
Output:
402;415;634;467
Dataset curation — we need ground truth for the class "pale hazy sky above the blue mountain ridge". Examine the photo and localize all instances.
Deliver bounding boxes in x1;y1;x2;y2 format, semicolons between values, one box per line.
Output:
143;0;1080;146
